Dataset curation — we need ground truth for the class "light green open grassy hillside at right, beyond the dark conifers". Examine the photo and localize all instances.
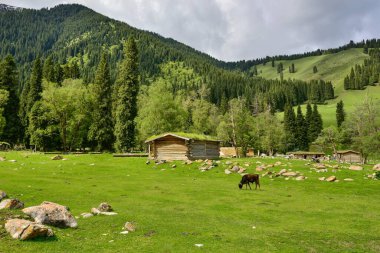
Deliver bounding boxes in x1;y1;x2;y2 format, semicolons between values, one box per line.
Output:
264;48;380;127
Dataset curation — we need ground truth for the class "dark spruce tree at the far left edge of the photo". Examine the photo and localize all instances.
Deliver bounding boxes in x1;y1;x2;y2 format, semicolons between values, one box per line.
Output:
0;55;23;144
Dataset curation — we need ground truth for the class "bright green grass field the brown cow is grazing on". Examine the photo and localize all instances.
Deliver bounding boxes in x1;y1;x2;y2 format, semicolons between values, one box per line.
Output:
0;152;380;252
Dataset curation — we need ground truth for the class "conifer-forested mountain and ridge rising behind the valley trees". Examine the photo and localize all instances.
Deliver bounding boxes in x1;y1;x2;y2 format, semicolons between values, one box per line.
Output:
0;4;379;116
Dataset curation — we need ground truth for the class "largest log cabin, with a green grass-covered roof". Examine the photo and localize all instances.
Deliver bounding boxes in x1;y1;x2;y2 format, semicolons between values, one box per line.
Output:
145;133;220;160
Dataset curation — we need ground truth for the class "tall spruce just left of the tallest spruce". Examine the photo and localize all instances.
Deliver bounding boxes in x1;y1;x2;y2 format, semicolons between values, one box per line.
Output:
88;53;114;150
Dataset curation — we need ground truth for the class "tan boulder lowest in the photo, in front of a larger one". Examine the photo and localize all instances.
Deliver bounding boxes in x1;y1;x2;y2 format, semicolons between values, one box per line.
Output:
5;219;54;240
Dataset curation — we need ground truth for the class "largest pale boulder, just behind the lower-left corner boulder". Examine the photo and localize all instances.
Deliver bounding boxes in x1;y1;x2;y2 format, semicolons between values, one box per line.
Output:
22;201;78;228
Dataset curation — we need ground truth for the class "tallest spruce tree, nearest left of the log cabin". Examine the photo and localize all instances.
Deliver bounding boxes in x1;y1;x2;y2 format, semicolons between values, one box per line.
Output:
114;37;139;152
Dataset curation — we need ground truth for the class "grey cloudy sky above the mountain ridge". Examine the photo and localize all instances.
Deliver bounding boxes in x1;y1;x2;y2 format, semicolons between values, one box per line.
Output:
0;0;380;61
